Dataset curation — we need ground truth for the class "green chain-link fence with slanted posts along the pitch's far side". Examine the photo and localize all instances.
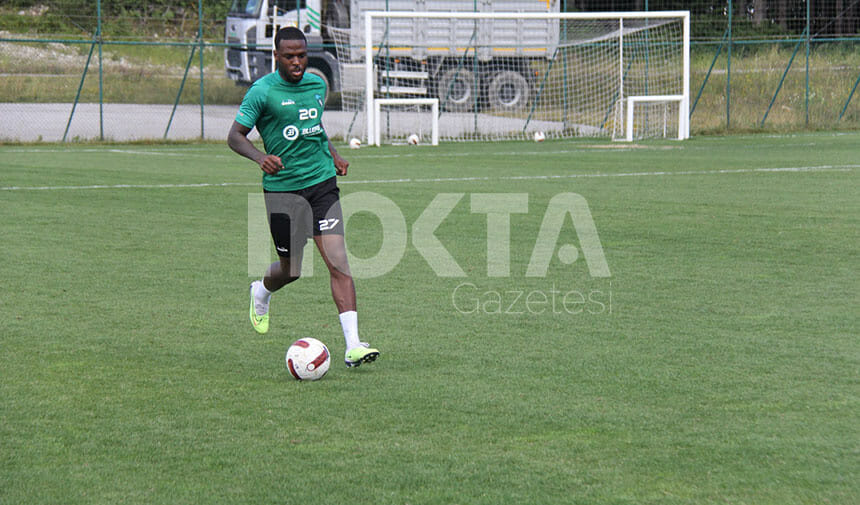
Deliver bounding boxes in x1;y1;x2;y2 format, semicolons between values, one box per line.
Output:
0;0;860;141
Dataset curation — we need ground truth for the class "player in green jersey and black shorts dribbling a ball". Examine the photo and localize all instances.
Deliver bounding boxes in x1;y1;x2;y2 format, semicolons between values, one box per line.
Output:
227;27;379;367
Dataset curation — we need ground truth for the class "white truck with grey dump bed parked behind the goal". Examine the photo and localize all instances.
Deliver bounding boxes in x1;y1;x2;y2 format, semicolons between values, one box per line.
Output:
225;0;560;111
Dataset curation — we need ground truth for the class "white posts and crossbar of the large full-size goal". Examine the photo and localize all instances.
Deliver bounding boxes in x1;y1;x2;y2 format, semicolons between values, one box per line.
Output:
363;11;690;144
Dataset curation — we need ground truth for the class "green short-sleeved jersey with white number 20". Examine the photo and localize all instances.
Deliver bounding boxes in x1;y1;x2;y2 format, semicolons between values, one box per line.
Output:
236;72;335;191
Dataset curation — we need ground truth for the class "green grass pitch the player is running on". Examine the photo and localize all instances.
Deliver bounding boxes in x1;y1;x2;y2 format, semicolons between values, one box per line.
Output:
0;133;860;505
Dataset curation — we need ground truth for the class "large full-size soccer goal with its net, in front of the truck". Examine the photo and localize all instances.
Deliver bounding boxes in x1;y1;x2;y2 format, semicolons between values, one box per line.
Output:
336;10;690;143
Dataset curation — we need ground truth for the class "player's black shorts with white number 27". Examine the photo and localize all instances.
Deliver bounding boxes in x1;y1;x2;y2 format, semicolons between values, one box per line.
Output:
264;177;343;257
